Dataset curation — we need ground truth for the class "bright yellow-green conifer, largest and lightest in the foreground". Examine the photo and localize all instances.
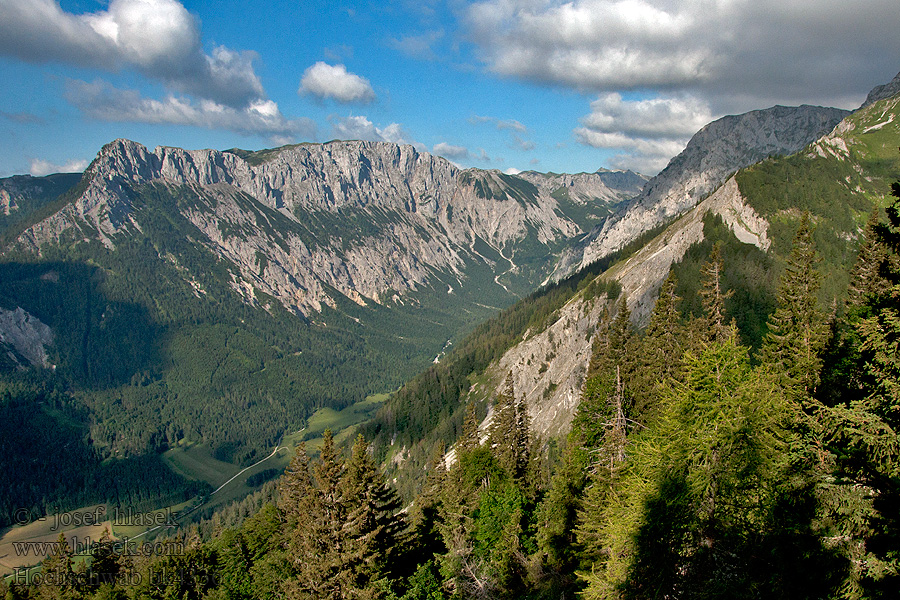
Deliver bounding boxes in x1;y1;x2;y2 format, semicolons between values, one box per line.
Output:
582;333;839;598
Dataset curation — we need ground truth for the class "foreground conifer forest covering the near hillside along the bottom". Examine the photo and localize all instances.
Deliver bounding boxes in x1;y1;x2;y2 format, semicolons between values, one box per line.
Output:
9;182;900;600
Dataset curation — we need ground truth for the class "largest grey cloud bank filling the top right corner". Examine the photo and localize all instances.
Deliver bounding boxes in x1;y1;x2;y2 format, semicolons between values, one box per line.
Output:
465;0;900;110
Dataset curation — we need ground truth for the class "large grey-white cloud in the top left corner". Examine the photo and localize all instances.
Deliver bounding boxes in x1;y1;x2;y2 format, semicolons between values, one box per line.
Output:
0;0;265;108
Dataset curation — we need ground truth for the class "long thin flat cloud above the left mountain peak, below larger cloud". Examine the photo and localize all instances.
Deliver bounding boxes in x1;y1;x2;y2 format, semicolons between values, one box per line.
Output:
66;80;315;143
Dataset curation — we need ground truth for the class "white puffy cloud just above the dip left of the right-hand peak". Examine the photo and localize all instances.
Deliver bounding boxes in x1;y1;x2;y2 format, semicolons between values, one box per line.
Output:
574;93;715;174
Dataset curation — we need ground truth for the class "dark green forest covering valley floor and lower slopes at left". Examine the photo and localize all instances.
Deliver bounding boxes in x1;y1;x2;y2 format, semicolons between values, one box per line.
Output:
0;176;506;524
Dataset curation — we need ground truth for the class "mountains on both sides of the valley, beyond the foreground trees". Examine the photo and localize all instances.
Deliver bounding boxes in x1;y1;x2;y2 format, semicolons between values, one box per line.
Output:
0;70;898;528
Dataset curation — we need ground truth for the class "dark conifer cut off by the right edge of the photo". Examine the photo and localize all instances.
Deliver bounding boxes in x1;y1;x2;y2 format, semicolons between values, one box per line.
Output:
827;182;900;597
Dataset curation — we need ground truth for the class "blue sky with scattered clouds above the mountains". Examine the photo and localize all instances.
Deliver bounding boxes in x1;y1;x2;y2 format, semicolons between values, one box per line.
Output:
0;0;900;176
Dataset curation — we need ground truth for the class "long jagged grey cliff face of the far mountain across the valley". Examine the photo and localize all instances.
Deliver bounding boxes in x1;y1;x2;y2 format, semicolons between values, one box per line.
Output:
8;140;640;314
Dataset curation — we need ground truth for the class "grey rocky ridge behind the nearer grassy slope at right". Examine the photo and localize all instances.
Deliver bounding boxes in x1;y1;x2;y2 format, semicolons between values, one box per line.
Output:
555;105;849;276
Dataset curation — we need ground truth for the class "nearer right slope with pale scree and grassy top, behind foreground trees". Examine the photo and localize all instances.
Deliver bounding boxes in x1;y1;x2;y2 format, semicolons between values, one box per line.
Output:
370;88;900;492
